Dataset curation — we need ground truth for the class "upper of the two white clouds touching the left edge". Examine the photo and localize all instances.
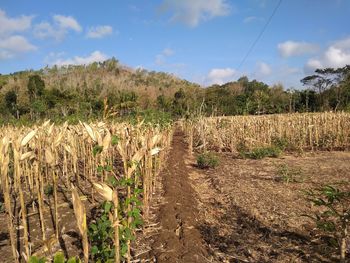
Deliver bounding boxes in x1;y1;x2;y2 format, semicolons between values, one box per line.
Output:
0;9;33;36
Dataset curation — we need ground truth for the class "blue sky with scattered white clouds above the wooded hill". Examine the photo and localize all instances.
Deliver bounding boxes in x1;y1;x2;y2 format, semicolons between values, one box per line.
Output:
0;0;350;89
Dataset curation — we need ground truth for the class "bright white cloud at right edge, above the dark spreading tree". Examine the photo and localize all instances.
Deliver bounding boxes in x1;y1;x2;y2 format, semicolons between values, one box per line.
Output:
304;37;350;73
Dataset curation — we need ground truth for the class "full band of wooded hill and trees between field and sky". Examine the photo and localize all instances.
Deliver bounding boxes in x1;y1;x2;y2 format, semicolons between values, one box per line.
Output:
0;58;350;123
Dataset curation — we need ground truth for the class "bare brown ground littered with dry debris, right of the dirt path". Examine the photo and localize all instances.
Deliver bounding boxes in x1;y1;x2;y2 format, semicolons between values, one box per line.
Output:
189;152;350;262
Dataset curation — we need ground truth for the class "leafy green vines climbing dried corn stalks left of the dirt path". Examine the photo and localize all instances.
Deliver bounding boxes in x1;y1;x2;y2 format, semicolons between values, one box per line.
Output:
88;162;143;263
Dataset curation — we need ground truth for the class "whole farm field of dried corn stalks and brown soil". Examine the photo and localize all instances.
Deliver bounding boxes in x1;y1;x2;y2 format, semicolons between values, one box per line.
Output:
0;113;350;262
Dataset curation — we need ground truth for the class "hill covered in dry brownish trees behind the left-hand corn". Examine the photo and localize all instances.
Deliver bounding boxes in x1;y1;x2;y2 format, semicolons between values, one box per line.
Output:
0;58;201;122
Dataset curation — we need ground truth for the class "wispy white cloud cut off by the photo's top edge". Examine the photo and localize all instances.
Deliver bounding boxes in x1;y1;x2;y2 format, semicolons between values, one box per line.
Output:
160;0;231;27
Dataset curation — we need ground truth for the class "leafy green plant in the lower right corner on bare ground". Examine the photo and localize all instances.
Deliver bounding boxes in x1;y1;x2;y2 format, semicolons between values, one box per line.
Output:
305;185;350;262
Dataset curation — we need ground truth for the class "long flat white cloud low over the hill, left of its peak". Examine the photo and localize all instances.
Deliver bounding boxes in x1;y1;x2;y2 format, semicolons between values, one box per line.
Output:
46;50;108;66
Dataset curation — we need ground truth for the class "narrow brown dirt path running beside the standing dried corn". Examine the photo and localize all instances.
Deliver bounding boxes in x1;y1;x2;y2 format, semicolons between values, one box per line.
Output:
151;130;208;263
